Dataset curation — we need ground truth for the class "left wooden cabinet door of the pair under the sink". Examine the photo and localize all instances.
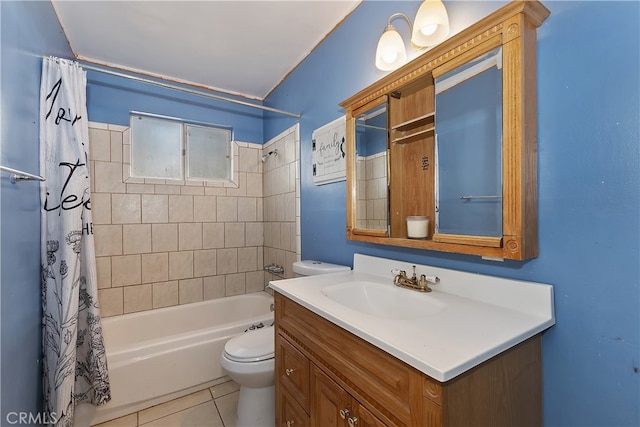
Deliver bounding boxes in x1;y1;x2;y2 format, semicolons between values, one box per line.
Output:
311;366;353;427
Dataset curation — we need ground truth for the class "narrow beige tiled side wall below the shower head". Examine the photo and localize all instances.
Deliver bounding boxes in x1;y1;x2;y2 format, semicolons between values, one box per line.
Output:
262;125;301;281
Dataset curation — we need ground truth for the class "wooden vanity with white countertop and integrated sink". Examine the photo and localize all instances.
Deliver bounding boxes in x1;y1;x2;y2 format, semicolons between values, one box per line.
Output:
270;254;555;427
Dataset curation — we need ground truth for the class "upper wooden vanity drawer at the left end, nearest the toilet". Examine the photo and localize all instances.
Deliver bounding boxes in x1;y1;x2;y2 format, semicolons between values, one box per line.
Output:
276;334;310;413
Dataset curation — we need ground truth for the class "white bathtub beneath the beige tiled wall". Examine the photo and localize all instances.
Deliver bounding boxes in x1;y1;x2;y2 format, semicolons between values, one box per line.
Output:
74;292;273;427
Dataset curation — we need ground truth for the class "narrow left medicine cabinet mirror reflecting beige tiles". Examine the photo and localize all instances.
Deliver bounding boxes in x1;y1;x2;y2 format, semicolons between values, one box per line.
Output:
355;103;389;231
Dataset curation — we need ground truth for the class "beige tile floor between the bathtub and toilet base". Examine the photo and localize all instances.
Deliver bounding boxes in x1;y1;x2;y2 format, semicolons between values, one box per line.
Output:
95;381;240;427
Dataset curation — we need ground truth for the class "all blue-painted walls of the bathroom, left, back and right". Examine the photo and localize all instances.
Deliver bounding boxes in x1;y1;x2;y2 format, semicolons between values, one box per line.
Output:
0;1;640;426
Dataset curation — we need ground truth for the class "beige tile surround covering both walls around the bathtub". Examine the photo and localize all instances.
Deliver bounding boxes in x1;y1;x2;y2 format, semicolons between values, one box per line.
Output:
89;123;268;317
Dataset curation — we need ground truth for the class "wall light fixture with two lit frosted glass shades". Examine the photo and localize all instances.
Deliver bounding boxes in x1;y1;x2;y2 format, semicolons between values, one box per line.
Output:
376;0;449;71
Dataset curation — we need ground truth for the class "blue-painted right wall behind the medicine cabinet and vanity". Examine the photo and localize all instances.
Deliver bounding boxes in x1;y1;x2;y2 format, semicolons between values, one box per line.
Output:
265;1;640;426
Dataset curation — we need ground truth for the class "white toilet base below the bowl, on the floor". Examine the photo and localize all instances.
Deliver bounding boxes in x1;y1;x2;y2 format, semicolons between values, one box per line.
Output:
236;386;276;427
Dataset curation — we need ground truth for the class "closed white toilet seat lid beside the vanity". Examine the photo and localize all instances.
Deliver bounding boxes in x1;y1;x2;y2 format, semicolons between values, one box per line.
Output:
224;326;275;363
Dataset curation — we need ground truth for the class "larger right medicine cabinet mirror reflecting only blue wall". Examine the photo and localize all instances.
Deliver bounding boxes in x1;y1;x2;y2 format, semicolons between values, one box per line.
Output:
435;47;502;237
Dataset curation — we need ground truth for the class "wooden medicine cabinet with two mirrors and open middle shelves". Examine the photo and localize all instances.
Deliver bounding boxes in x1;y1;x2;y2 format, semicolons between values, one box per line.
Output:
340;1;550;260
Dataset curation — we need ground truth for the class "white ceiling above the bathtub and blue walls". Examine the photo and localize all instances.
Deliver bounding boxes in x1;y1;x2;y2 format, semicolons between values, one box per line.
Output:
51;0;362;100
